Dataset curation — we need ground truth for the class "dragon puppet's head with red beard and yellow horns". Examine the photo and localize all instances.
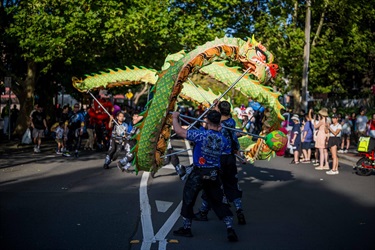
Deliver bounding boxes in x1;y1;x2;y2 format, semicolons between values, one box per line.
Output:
239;36;278;84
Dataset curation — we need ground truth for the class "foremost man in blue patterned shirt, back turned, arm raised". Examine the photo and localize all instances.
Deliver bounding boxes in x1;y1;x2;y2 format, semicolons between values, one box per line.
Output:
172;110;238;242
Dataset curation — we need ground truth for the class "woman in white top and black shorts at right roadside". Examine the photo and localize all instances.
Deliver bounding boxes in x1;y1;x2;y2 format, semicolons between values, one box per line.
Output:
326;114;342;175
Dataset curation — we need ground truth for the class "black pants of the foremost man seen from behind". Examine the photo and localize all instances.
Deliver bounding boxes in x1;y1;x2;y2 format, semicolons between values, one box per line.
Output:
181;167;233;219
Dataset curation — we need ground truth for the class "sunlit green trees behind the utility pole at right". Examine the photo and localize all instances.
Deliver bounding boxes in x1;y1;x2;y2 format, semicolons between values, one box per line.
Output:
244;0;375;112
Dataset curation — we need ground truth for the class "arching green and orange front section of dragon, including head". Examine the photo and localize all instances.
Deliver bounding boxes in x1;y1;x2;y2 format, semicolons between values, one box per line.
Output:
135;38;282;171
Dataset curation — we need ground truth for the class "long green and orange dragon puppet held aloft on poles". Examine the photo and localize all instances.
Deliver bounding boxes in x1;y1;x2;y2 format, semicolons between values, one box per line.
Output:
73;37;287;173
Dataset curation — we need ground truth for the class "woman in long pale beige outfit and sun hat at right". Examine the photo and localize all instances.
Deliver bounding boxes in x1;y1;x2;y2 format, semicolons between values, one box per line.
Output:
314;108;329;170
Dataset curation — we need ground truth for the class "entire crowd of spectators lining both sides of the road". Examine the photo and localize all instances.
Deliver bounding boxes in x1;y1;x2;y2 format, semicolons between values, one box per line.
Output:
1;93;375;168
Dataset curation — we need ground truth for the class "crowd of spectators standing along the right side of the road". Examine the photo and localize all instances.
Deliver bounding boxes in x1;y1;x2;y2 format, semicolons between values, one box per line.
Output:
282;108;375;175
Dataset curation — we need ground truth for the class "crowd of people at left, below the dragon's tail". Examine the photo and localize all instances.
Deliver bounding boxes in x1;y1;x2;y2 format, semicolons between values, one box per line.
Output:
19;98;144;157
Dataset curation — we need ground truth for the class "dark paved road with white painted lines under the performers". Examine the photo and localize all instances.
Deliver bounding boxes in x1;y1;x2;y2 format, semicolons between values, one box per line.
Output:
0;140;375;249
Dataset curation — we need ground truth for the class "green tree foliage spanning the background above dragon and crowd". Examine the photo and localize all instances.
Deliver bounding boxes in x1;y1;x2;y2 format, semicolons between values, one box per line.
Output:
0;0;375;112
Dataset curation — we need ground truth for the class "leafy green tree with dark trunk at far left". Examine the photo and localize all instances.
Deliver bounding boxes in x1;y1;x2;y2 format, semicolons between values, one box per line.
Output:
1;0;125;134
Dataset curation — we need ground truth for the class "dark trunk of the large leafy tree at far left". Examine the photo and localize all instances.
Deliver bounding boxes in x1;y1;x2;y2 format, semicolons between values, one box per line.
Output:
14;61;36;136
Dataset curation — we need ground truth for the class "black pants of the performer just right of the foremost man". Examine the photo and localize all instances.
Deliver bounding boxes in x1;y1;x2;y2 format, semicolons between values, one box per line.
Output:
220;154;242;202
